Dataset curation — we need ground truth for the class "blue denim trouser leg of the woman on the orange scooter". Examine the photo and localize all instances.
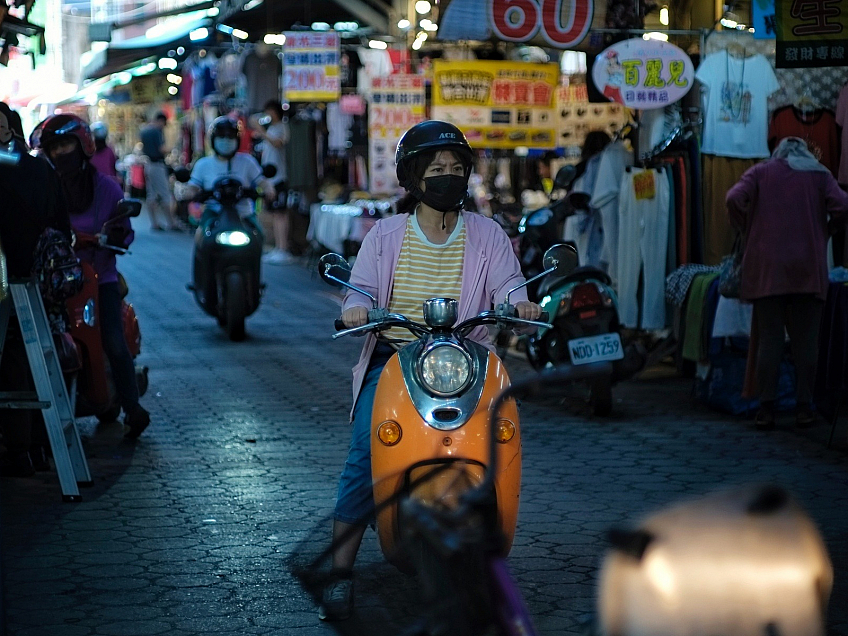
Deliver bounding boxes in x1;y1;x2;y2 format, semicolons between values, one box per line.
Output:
333;343;394;526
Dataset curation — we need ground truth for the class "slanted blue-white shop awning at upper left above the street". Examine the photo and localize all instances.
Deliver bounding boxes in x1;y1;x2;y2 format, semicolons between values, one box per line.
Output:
82;12;212;79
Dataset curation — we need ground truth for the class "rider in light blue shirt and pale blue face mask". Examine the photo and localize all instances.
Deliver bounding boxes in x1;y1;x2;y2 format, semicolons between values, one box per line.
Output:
181;117;277;219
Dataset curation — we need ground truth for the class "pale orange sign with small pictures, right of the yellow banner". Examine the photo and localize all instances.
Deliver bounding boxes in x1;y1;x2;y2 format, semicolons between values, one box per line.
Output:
556;84;630;148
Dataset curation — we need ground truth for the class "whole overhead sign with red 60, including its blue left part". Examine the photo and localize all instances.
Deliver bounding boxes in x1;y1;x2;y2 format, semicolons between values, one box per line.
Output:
438;0;607;49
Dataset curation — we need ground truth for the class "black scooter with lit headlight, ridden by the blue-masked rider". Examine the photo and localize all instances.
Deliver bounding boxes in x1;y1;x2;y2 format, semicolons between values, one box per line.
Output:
177;166;276;342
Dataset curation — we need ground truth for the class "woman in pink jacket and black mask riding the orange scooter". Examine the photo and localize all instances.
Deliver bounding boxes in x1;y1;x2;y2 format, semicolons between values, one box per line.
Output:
318;121;541;620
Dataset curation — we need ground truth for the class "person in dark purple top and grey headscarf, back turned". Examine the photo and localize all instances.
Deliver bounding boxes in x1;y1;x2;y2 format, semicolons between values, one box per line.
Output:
727;137;848;430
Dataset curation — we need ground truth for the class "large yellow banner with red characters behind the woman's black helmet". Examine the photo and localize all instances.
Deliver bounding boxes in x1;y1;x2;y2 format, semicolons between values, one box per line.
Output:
432;60;559;149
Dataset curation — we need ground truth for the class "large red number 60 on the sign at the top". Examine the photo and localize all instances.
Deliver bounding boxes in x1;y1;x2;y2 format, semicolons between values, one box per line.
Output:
489;0;594;48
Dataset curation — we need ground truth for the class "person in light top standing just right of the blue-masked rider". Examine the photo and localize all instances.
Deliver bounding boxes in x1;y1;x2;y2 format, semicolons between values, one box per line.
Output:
251;99;293;265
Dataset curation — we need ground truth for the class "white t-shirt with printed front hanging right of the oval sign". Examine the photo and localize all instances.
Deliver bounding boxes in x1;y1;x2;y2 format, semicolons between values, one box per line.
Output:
695;50;780;159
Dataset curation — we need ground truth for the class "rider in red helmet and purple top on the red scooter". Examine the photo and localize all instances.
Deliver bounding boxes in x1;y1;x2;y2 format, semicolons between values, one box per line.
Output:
37;114;150;438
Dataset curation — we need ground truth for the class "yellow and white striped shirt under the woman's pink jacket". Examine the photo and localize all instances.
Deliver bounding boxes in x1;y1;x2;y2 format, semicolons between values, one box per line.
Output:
387;214;465;341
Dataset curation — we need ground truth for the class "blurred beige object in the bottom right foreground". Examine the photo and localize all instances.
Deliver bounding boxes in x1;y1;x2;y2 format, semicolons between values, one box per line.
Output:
598;485;833;636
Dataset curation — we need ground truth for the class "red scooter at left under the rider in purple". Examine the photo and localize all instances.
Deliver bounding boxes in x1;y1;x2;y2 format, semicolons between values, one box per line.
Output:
65;199;149;422
